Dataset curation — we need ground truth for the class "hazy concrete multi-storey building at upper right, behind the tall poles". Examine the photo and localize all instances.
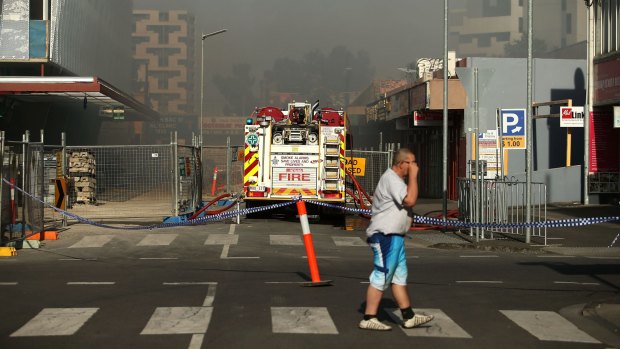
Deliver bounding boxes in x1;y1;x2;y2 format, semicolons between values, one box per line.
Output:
448;0;586;57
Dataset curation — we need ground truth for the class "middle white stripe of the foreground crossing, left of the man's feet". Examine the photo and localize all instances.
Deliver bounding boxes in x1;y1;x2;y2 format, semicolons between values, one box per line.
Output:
271;307;338;334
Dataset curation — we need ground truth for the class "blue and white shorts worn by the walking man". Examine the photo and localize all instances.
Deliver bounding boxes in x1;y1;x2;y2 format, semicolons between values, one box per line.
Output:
367;233;407;291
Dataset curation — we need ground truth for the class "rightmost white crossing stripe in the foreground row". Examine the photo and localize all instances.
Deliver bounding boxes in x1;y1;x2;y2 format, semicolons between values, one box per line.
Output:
500;310;600;343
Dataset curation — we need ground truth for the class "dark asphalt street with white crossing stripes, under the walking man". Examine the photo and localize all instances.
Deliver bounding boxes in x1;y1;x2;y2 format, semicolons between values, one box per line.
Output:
0;219;620;349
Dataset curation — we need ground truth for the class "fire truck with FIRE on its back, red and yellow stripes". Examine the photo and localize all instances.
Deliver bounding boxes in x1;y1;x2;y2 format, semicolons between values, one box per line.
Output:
243;102;347;207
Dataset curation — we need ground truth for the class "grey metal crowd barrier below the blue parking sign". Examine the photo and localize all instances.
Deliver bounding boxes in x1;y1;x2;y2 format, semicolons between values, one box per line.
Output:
457;178;547;245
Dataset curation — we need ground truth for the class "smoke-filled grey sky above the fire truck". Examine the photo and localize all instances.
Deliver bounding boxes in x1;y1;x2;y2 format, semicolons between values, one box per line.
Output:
134;0;443;80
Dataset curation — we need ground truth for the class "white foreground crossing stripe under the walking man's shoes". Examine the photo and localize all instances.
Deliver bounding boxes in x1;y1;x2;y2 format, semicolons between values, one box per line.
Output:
386;309;471;338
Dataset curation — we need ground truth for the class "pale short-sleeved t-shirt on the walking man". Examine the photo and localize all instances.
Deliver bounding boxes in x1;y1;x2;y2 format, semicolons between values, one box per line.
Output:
366;168;413;237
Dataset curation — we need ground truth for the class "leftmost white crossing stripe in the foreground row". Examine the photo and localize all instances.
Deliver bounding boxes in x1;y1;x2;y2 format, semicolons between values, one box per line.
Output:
11;308;99;337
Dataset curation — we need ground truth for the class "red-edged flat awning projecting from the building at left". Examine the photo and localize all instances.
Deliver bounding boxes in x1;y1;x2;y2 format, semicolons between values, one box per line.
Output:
0;76;159;121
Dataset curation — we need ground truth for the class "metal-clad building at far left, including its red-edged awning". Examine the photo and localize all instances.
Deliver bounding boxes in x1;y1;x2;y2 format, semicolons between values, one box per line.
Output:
0;0;151;144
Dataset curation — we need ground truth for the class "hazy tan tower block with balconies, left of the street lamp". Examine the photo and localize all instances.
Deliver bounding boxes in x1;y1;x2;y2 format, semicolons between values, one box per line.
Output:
132;9;199;143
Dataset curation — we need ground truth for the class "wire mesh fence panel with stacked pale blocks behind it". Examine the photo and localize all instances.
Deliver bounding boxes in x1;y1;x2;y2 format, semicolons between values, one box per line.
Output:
66;145;177;221
